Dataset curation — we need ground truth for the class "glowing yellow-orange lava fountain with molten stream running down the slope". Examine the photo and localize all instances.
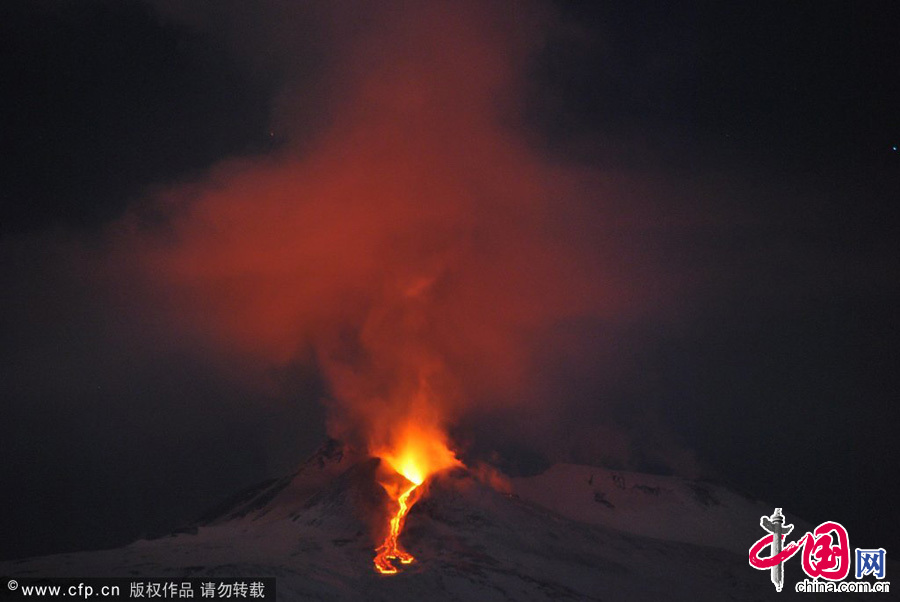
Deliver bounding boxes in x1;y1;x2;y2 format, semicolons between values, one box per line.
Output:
375;424;462;575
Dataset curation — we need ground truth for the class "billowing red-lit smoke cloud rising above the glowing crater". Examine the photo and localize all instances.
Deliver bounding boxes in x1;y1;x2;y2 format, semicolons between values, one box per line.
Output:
105;2;684;466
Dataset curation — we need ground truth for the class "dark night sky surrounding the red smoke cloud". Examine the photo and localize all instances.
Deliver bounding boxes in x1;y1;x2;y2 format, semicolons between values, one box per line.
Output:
0;1;900;558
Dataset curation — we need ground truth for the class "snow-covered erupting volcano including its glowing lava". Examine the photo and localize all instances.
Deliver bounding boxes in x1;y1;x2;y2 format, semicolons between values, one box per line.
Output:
0;436;788;602
